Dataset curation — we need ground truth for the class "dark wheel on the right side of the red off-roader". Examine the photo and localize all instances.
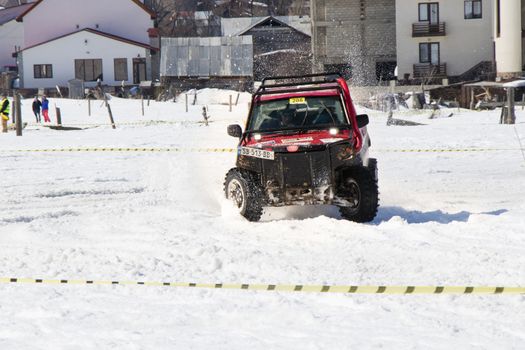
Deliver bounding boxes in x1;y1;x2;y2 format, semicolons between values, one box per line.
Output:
339;160;379;222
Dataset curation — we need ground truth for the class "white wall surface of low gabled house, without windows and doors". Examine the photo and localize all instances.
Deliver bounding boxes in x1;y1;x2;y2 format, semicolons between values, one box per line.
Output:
19;32;149;88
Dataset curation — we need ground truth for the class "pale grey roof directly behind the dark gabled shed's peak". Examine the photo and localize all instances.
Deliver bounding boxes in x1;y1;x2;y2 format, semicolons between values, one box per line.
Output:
221;16;312;36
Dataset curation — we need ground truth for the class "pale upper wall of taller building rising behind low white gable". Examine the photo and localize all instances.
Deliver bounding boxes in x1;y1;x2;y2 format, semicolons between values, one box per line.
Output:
23;0;153;47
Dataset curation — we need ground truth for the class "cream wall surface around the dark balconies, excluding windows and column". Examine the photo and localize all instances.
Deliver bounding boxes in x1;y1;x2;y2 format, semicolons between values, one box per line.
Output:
396;0;494;79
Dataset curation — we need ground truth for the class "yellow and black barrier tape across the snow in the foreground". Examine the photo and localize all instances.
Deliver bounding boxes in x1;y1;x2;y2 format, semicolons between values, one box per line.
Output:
0;278;525;295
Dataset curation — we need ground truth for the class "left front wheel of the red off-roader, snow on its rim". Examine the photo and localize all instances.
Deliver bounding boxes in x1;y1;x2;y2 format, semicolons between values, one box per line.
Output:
224;168;263;221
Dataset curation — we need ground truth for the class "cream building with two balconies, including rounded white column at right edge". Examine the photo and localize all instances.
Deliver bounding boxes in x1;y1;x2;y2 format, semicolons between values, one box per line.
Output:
396;0;525;80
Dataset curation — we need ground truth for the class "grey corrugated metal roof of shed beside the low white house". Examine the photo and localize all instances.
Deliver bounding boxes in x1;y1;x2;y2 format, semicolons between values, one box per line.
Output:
160;35;253;77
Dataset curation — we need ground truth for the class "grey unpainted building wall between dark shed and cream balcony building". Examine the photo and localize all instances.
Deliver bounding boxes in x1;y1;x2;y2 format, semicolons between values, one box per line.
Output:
311;0;396;85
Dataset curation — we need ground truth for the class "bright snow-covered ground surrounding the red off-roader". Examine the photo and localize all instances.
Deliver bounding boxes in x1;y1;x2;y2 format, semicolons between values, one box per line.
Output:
0;91;525;349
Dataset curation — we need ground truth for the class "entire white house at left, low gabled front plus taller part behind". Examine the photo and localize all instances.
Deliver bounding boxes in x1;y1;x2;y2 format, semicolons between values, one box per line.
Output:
17;0;157;88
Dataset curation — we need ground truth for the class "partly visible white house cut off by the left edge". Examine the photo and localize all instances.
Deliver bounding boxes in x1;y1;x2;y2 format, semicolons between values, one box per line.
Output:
0;4;31;72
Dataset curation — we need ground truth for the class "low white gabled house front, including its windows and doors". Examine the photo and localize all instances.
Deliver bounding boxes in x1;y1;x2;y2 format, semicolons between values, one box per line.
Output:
19;29;156;88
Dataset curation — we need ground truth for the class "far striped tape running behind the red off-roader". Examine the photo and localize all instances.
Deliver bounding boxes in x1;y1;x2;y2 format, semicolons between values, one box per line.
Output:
0;147;521;153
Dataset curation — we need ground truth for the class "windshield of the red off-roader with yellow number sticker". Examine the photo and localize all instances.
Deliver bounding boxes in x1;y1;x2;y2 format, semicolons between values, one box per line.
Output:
248;96;348;132
